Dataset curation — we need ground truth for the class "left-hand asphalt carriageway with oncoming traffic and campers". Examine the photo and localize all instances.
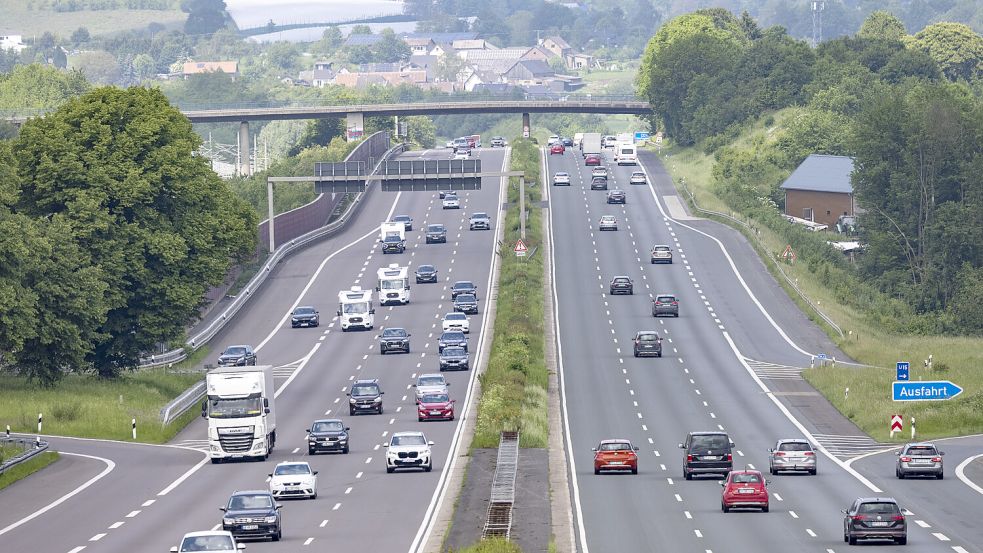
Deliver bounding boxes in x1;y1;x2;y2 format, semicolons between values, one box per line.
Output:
0;150;506;553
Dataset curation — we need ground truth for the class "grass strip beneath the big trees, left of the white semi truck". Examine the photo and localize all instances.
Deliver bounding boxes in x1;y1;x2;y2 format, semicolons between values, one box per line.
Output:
0;347;208;443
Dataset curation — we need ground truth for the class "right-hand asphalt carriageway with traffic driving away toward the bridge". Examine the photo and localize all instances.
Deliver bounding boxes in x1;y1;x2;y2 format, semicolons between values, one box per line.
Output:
544;146;983;553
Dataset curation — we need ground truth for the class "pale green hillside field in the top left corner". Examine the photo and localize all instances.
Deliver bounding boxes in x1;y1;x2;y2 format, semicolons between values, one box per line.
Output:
0;0;188;37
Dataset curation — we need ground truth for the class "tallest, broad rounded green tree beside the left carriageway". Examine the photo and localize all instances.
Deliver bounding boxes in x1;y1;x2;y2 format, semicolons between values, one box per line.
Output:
13;88;257;376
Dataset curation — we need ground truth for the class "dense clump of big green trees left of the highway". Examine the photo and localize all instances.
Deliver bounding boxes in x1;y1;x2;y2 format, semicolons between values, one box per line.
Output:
0;88;257;384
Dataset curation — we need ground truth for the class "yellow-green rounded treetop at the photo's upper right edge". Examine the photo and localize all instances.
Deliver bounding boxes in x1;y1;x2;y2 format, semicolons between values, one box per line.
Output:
909;23;983;81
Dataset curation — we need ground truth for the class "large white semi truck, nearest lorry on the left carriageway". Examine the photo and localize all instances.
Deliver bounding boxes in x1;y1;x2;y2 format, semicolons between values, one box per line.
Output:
201;365;276;463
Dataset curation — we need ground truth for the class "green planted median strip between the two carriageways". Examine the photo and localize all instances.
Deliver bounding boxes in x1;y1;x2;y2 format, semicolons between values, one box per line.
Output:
471;139;549;448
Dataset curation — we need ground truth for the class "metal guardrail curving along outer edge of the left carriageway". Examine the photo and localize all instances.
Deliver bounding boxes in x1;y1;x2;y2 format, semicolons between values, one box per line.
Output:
156;143;406;425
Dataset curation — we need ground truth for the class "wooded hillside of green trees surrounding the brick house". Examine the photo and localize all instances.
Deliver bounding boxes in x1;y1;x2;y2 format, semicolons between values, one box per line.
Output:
638;10;983;334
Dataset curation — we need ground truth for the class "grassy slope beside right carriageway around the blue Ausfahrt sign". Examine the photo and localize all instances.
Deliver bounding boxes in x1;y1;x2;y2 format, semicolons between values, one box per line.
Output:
662;110;983;442
